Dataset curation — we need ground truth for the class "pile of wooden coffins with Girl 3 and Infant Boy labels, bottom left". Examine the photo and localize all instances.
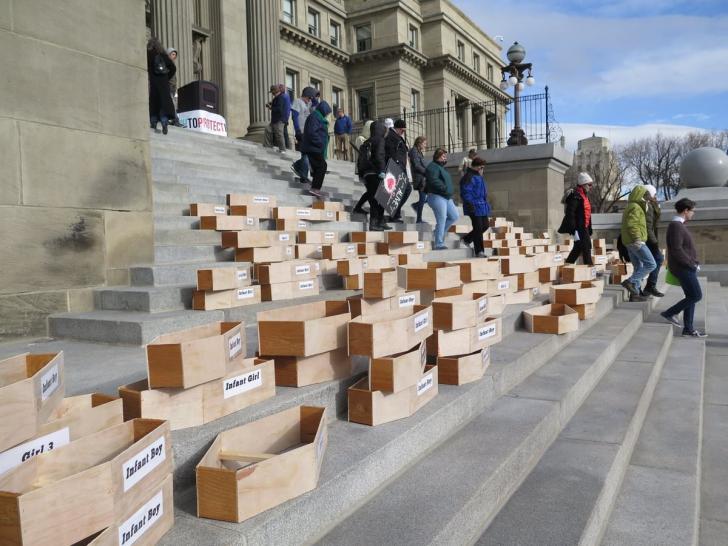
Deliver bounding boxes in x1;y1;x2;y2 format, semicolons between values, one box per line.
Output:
0;353;174;545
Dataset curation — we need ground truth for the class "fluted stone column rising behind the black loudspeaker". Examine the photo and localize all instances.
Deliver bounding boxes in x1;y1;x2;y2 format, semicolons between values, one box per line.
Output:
152;0;192;88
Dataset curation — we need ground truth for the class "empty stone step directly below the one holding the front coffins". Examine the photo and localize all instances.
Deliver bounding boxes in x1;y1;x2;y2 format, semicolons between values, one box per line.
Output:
319;309;642;544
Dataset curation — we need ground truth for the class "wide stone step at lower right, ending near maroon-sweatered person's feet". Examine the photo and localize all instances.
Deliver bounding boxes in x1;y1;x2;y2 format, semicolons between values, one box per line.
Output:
602;334;705;546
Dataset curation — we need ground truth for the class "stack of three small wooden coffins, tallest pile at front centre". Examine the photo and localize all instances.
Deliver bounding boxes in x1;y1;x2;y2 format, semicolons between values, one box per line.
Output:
348;305;438;426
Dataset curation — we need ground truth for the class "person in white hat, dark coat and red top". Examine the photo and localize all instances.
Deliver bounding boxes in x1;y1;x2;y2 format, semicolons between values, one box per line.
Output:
557;173;594;265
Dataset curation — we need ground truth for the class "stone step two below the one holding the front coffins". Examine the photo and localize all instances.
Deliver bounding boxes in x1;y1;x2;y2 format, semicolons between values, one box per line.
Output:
476;324;672;546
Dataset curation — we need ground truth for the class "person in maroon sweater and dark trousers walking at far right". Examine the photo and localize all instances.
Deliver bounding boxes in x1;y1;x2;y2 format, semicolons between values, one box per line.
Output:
660;198;708;338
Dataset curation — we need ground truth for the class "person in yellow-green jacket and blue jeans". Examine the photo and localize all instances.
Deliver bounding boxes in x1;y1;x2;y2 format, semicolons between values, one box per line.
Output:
622;185;657;301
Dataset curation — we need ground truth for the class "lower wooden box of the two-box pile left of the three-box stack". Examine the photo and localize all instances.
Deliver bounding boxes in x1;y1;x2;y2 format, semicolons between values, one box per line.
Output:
272;347;351;387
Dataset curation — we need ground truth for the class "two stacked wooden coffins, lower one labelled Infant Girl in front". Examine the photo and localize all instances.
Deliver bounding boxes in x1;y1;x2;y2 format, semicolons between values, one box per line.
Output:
119;322;275;430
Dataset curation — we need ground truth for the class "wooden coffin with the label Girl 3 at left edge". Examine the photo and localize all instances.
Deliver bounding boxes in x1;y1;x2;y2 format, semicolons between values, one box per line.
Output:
0;394;124;475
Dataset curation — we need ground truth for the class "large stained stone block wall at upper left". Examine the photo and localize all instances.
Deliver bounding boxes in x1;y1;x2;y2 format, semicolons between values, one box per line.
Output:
0;0;153;338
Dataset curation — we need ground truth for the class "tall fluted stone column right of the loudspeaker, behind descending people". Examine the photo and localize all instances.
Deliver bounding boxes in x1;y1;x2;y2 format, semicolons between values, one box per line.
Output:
245;1;283;142
